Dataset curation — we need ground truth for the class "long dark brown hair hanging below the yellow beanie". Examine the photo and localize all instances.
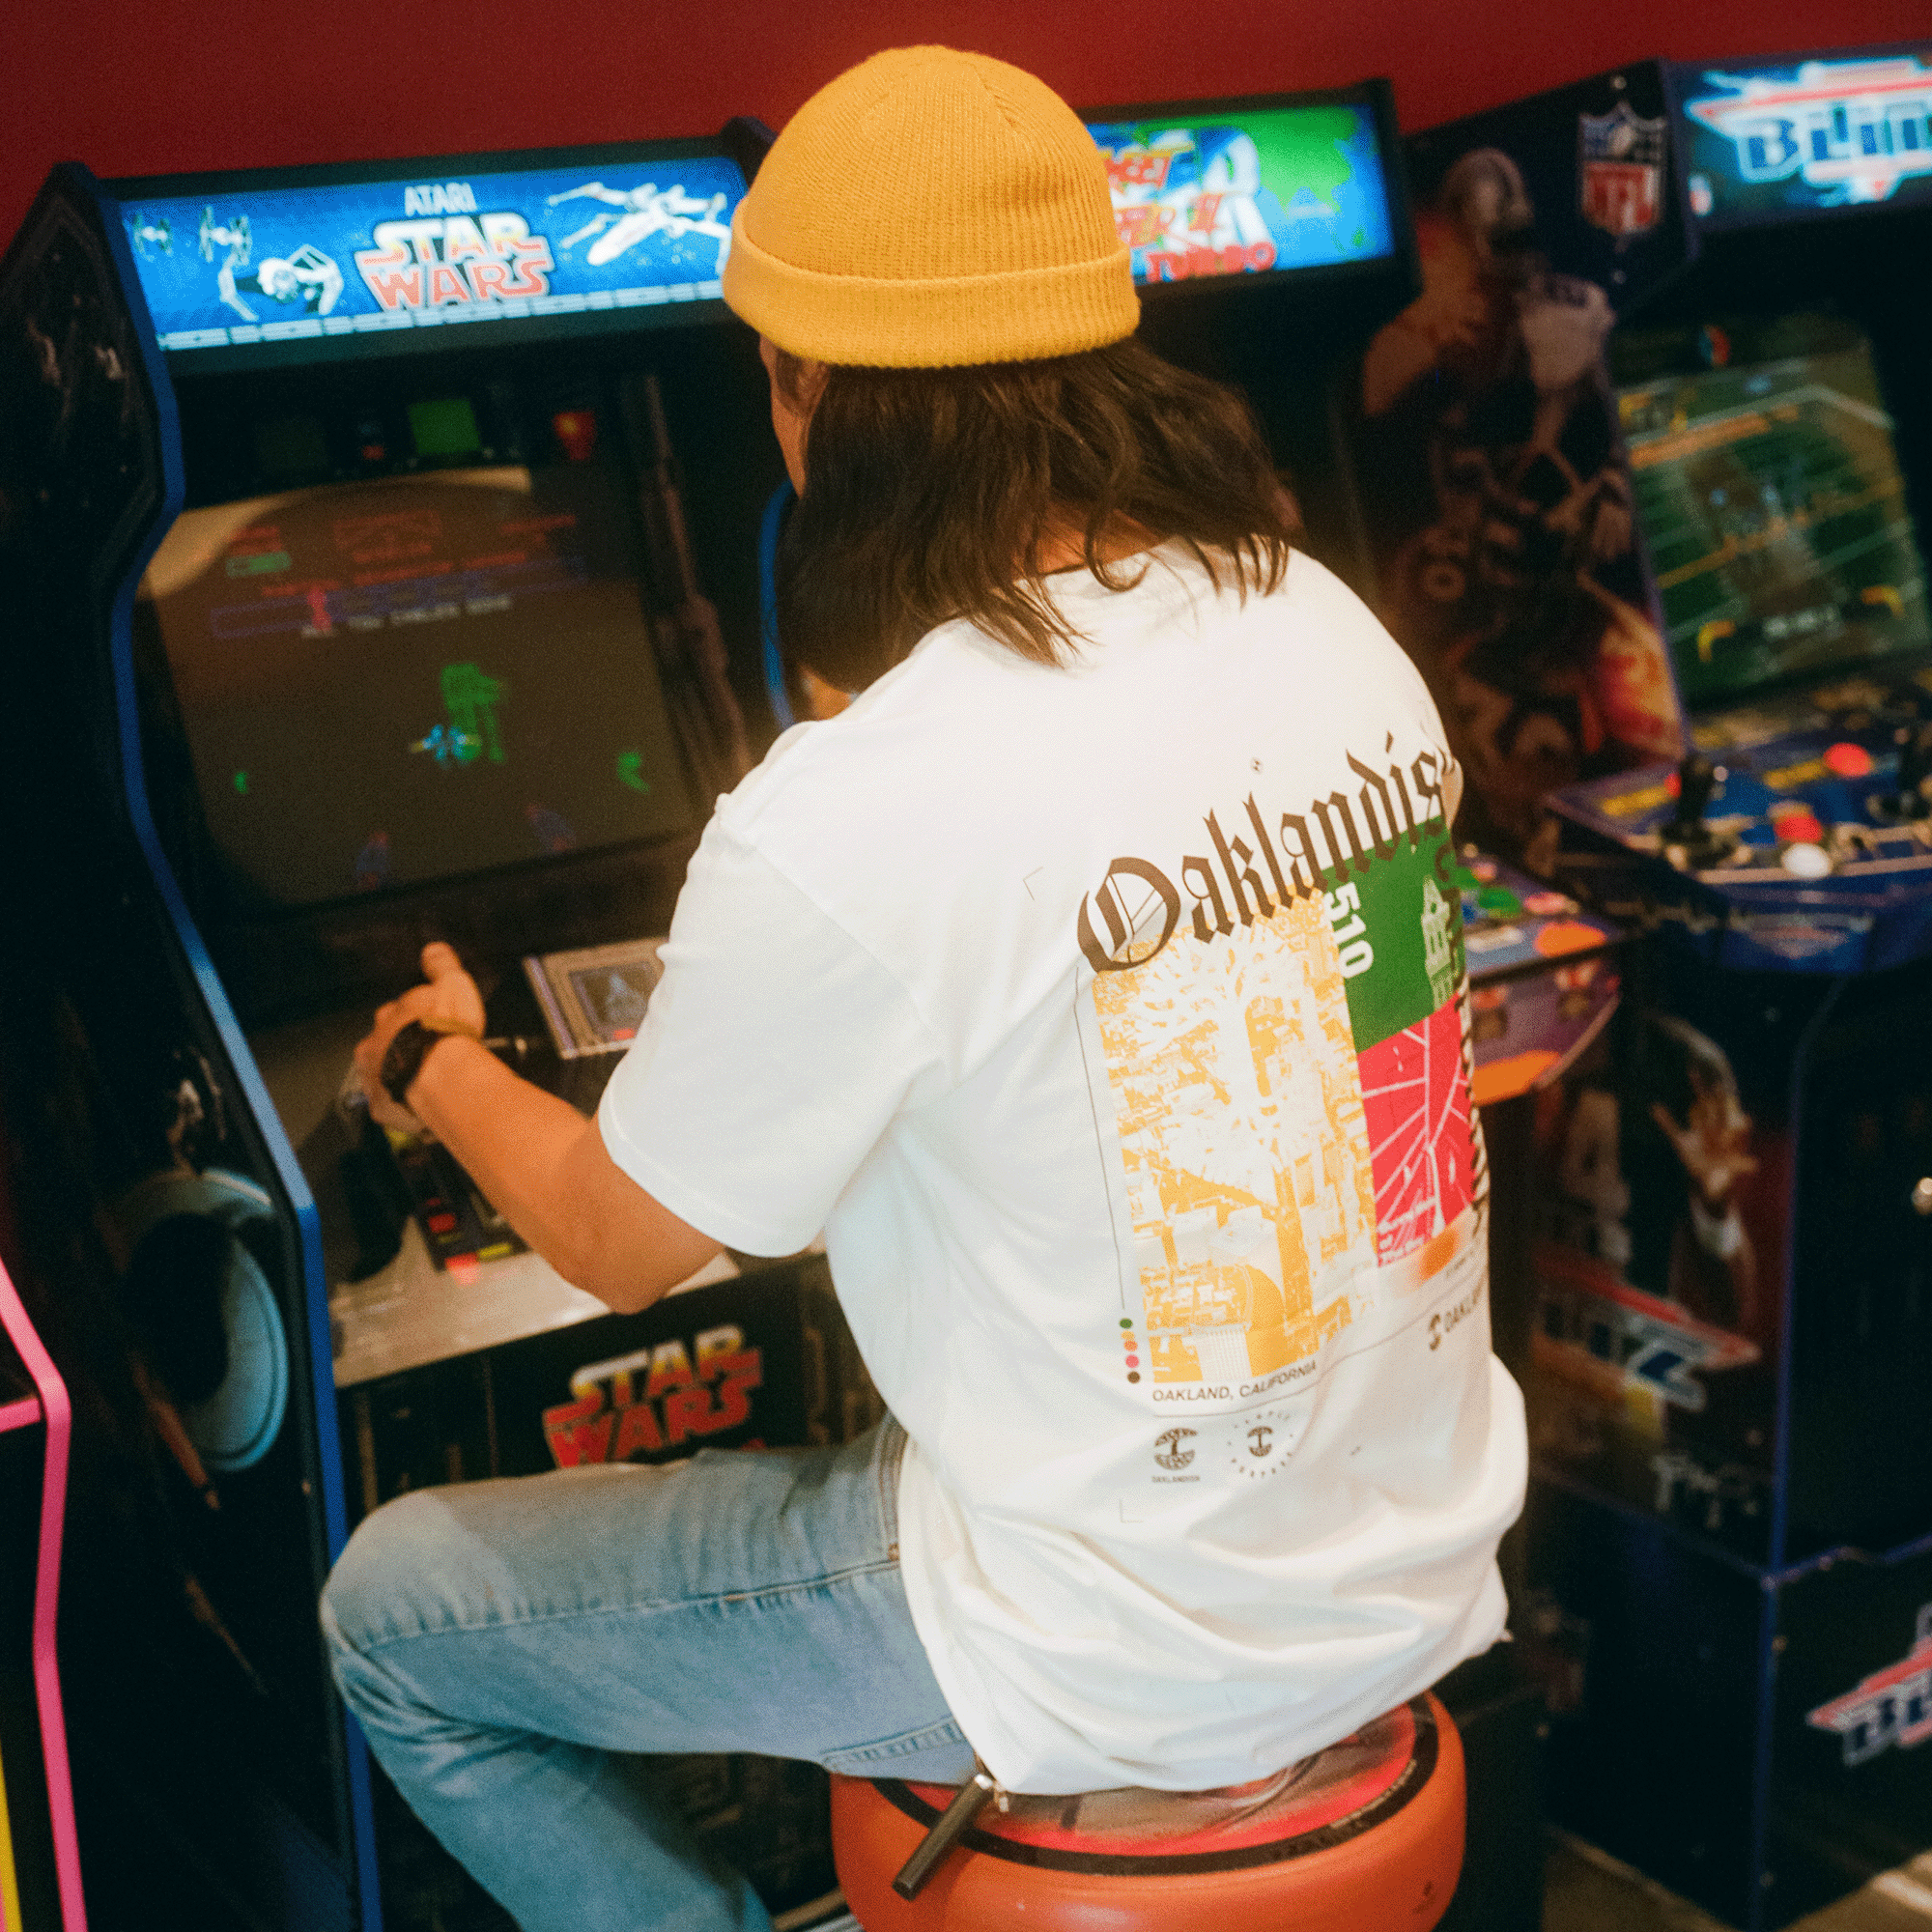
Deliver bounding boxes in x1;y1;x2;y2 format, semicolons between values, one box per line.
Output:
777;338;1293;692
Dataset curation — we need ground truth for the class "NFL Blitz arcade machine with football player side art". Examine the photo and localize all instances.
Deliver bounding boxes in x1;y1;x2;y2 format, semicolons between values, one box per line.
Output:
1358;34;1932;1926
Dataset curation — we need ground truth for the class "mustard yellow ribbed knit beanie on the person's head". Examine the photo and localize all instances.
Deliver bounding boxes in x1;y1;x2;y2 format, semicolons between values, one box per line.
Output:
724;46;1140;369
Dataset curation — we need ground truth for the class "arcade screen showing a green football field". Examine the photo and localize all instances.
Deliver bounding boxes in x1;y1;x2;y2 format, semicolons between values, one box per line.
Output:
1617;317;1932;709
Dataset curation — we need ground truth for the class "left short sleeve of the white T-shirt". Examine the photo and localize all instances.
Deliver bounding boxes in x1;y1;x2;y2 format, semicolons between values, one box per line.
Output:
597;817;941;1254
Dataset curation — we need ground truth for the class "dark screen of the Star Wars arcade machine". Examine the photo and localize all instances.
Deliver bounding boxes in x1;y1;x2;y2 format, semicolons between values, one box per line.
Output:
143;456;697;908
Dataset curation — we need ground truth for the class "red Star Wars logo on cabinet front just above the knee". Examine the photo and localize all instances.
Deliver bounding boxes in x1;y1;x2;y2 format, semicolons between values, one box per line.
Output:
543;1323;765;1468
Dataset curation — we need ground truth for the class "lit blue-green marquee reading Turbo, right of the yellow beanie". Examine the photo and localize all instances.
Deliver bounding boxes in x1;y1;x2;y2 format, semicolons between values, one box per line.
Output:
1088;100;1395;282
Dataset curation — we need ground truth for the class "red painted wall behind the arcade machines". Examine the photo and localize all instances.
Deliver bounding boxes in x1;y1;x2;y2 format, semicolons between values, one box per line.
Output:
14;0;1928;257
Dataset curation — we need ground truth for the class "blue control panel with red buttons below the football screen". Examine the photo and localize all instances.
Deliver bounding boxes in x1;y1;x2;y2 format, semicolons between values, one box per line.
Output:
1551;672;1932;972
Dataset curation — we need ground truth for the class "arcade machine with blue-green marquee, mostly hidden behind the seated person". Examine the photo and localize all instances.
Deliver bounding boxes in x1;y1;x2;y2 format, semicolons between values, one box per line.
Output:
1088;89;1631;1182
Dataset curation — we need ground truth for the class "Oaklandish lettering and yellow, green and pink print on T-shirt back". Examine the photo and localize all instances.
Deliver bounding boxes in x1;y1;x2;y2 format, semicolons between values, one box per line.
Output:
1078;734;1480;1430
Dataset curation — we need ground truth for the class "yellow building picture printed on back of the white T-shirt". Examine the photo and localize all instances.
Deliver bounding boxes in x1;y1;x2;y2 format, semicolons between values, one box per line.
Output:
1094;895;1376;1383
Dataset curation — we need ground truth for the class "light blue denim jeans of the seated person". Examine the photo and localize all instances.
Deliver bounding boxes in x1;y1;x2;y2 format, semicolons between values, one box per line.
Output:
323;1418;972;1932
